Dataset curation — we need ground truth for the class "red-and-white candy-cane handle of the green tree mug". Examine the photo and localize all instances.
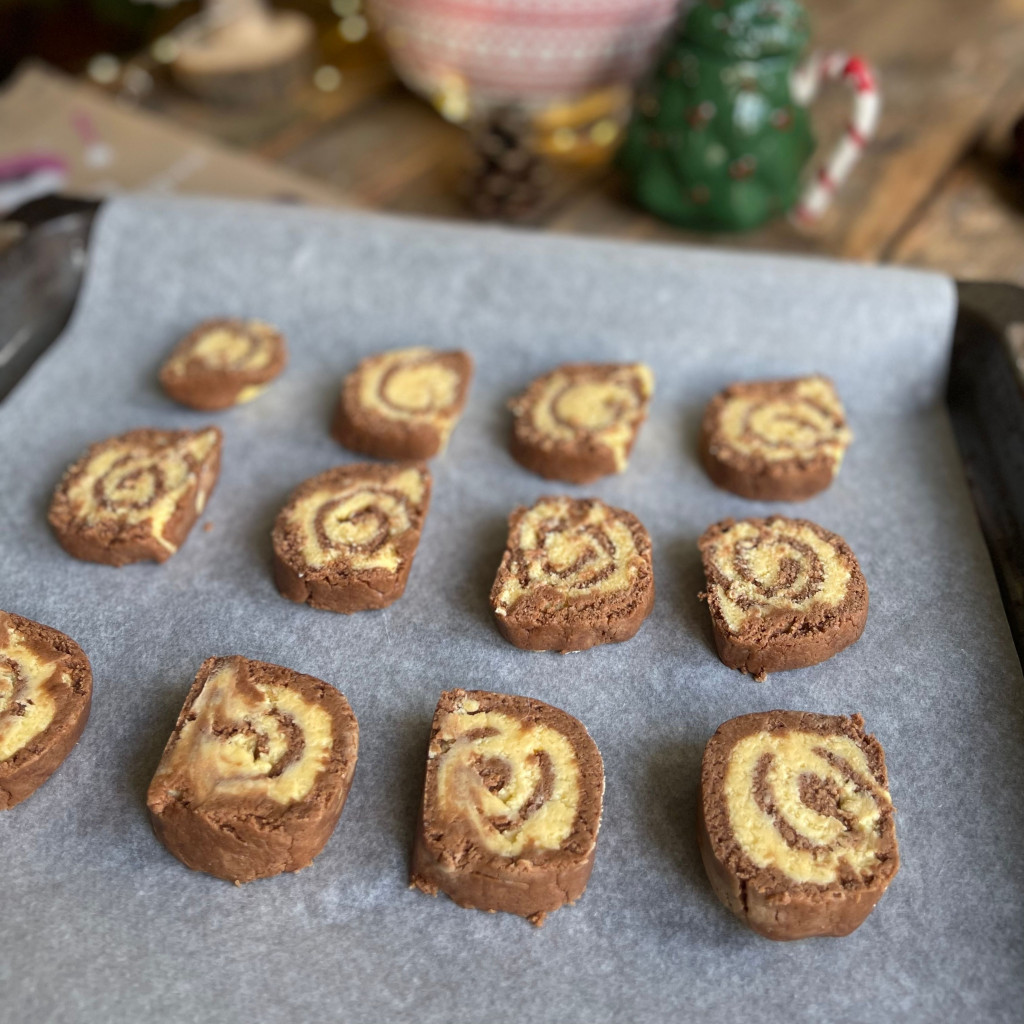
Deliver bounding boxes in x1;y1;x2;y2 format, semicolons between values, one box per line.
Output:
790;50;882;224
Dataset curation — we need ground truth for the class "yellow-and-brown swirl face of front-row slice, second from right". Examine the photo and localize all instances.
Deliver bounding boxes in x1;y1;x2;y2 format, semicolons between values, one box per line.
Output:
429;698;582;857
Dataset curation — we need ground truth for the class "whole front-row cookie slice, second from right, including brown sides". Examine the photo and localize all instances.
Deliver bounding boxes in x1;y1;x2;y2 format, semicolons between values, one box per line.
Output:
412;690;604;925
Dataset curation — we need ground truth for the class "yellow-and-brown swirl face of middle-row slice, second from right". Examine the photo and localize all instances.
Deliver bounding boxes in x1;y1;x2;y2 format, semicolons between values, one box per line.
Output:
493;498;648;615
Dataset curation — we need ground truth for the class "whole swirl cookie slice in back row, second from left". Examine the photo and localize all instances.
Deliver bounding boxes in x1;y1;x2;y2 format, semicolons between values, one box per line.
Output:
331;348;473;459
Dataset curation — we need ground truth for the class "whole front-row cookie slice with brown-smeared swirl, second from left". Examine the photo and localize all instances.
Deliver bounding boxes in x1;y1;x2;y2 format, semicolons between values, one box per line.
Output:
146;655;359;883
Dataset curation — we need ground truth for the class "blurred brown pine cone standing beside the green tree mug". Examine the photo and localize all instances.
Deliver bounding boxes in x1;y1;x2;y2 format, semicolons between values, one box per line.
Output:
465;106;547;221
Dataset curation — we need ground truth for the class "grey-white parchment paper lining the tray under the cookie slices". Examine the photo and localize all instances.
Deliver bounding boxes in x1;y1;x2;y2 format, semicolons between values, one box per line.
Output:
0;199;1024;1022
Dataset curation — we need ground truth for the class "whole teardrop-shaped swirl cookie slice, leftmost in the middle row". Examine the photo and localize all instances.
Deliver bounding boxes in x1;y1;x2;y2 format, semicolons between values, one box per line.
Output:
49;427;221;565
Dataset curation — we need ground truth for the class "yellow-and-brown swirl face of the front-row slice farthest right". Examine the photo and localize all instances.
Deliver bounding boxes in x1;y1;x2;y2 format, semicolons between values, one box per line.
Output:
722;729;892;886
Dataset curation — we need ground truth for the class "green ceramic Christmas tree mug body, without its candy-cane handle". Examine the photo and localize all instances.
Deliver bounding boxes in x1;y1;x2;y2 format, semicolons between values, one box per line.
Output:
620;0;814;229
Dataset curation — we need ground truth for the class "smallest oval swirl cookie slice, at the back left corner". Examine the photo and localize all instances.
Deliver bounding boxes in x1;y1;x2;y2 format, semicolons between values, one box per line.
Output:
160;319;288;411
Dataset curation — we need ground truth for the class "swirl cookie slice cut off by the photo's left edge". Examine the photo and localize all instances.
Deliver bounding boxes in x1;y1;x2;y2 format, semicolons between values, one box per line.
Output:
0;611;92;811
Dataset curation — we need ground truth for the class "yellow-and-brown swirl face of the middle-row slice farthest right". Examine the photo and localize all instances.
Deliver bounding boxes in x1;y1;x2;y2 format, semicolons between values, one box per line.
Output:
701;516;853;633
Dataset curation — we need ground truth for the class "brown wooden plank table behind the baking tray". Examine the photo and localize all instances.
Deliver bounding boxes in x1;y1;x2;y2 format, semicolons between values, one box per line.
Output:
92;0;1024;358
